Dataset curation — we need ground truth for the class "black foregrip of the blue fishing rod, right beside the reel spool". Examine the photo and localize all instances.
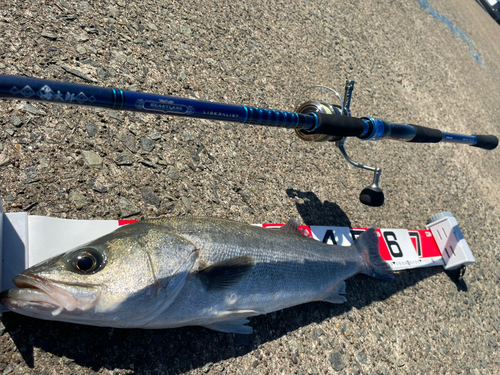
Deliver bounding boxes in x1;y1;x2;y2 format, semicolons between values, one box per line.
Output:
308;113;366;137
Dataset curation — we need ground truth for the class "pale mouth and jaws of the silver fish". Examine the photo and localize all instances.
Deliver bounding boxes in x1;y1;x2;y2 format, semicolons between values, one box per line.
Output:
0;274;97;317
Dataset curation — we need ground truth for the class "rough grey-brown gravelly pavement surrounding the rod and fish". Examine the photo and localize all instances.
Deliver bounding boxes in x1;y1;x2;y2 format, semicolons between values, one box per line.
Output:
0;0;500;375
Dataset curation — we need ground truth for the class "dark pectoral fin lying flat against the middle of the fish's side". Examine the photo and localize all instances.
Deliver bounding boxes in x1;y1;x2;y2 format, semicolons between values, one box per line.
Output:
198;256;255;291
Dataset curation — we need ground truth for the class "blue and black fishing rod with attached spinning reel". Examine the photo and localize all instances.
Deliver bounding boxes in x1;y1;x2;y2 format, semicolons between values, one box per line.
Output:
0;74;498;206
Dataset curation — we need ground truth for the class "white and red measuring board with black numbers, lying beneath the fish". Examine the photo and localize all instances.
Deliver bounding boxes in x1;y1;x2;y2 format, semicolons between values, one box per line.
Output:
0;201;475;290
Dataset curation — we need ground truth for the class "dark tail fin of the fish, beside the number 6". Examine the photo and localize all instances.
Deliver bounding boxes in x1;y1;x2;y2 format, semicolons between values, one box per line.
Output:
354;228;394;281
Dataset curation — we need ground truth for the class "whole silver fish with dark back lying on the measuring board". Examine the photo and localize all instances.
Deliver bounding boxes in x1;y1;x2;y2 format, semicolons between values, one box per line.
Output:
0;218;392;334
